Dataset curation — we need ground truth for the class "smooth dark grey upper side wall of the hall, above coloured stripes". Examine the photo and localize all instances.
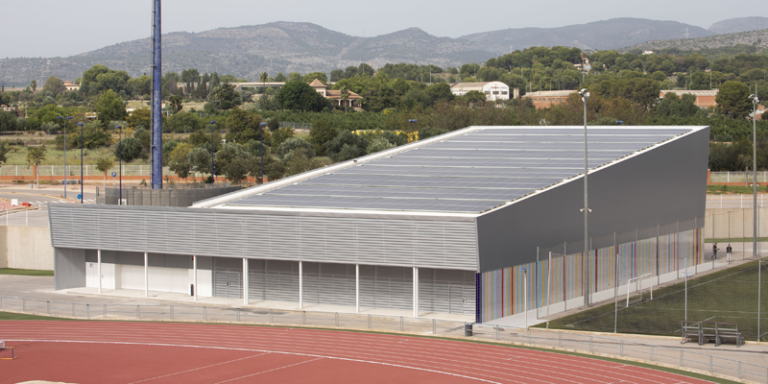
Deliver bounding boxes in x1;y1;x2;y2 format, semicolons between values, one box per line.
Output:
477;128;709;272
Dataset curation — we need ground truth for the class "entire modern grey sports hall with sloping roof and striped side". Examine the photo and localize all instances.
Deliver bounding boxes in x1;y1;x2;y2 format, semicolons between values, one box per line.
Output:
49;127;709;322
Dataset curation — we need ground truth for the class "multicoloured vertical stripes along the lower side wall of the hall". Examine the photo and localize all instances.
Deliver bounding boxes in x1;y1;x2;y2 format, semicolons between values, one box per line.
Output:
475;229;704;323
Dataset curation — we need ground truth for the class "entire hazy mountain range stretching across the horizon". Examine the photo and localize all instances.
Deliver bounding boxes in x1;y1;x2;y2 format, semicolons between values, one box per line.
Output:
0;18;768;86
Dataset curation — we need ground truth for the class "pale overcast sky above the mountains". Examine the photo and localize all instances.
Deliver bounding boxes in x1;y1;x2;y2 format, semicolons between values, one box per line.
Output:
0;0;768;58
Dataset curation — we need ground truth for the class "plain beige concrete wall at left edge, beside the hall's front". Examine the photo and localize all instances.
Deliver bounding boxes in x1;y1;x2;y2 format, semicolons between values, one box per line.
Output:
0;226;53;271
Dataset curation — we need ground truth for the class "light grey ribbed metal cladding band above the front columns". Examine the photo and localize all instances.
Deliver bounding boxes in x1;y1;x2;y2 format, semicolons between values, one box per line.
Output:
50;204;478;270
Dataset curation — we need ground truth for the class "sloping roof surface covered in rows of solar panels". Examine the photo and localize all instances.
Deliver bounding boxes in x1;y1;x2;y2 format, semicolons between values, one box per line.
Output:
227;127;690;213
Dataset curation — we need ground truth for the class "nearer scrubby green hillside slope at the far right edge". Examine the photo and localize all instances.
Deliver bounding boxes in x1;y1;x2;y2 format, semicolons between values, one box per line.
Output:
619;29;768;52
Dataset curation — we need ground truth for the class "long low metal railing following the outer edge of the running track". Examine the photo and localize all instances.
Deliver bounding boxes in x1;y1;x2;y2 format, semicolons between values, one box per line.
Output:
0;296;768;383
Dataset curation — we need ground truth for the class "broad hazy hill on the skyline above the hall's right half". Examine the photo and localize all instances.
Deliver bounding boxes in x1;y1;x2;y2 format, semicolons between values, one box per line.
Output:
462;18;713;53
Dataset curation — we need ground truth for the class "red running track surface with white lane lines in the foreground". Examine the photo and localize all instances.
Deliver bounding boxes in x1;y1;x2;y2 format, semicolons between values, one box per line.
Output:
0;321;720;384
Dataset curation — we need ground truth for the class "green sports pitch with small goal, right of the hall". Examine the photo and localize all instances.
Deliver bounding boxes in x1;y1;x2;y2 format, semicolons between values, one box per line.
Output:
539;260;768;340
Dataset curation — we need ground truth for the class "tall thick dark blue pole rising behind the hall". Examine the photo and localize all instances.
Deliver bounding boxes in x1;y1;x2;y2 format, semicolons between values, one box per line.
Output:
152;0;163;189
